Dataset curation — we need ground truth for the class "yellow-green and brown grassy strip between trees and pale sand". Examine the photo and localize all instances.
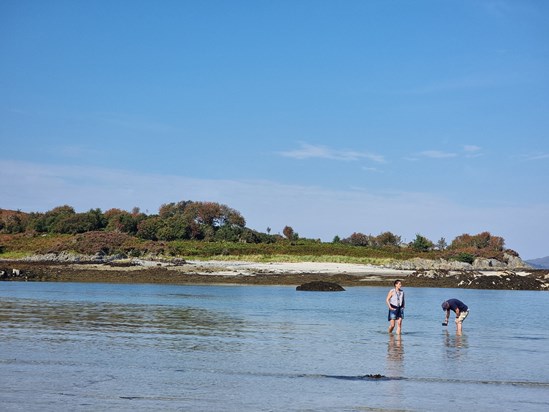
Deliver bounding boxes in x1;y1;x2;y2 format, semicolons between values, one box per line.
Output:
0;232;480;266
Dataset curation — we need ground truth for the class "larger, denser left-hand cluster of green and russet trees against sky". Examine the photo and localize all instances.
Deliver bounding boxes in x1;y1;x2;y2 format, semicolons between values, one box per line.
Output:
0;200;267;243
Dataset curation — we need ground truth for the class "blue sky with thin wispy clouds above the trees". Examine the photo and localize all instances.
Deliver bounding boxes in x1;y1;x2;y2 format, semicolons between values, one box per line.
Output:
0;0;549;259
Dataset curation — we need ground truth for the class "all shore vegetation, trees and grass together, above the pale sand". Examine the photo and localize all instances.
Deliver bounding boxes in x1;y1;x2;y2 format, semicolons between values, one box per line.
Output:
0;201;518;265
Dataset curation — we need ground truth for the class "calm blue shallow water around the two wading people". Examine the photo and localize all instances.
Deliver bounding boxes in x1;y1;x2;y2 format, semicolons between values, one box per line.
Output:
0;282;549;411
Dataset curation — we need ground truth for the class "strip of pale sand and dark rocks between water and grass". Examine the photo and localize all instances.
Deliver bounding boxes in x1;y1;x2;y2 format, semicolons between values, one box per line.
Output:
0;254;549;290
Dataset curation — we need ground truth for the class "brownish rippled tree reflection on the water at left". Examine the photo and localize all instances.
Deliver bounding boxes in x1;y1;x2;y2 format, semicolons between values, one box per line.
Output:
0;300;248;346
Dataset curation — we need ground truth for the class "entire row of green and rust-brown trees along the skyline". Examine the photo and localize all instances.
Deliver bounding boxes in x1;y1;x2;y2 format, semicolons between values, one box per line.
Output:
0;200;518;262
